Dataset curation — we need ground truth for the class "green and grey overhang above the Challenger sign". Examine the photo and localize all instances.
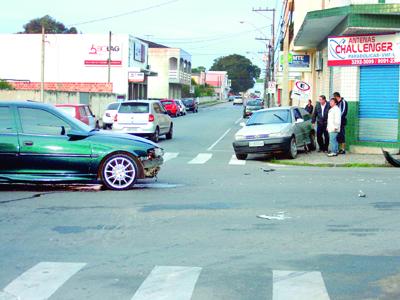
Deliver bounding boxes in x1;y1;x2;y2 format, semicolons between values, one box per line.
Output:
294;4;400;49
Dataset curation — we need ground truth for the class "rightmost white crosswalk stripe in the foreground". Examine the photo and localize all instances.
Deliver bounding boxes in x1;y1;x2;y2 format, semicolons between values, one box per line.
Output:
272;270;330;300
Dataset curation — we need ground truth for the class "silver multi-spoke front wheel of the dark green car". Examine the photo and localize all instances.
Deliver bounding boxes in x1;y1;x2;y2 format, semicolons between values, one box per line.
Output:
103;156;136;190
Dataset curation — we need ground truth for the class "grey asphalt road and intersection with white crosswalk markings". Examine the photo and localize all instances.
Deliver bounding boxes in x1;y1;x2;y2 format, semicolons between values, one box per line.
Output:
0;104;400;300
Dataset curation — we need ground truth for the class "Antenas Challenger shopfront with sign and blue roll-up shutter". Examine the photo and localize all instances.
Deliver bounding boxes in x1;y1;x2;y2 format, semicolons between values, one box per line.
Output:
327;34;400;151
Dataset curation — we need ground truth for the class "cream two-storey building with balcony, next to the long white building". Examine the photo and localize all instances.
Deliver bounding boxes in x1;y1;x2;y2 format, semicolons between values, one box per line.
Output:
145;41;192;99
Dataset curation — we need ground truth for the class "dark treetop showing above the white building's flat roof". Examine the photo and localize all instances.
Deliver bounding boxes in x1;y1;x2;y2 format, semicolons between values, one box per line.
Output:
19;15;78;34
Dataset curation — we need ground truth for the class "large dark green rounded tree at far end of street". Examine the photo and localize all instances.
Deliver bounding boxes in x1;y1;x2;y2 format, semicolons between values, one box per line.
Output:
210;54;261;93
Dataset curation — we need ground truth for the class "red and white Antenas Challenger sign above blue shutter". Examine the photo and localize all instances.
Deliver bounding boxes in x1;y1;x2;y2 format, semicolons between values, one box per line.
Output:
328;34;400;67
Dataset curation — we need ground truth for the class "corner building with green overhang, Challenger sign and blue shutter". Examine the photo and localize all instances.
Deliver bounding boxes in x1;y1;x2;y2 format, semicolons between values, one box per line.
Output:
278;0;400;153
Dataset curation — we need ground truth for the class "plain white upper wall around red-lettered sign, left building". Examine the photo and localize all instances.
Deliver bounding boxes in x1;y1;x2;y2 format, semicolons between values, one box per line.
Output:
0;34;147;94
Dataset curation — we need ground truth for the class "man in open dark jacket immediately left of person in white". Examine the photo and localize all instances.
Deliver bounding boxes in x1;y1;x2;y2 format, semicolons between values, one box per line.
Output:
312;95;330;152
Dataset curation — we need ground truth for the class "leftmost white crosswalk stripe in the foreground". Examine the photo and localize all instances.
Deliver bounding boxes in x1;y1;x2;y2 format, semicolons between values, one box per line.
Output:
4;262;86;300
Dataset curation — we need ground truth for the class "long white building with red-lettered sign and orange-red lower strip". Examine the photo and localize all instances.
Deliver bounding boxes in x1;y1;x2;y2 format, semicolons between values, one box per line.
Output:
0;34;155;99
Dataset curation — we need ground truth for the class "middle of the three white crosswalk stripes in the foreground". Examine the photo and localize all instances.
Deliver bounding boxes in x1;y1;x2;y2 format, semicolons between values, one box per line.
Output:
132;266;201;300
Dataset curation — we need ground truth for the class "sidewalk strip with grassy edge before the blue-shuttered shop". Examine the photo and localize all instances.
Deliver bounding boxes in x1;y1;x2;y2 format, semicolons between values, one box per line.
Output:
272;151;399;167
